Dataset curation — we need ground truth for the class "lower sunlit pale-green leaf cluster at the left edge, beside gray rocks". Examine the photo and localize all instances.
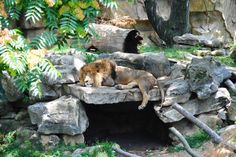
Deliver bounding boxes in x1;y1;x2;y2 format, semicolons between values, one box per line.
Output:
0;29;60;97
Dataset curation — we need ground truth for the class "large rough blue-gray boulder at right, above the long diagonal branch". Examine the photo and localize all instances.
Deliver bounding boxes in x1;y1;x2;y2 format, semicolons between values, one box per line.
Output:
186;57;231;99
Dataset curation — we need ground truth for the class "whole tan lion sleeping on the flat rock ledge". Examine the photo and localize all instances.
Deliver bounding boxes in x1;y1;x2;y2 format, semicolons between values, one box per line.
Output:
79;59;164;110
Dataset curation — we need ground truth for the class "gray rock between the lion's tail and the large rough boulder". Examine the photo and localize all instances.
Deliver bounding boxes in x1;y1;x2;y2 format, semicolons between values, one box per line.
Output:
162;79;191;106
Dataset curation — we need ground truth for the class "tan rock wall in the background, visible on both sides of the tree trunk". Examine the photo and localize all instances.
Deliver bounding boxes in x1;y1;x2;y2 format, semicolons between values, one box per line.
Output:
100;0;236;42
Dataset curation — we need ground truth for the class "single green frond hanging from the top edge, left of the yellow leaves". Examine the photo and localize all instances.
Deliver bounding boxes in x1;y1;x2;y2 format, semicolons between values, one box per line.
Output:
25;1;45;23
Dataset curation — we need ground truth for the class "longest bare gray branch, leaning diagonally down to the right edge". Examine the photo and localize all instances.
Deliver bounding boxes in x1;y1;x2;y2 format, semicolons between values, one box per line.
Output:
172;103;236;153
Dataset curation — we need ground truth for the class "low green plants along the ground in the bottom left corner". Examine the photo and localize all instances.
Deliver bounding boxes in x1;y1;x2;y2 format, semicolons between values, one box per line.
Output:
0;131;116;157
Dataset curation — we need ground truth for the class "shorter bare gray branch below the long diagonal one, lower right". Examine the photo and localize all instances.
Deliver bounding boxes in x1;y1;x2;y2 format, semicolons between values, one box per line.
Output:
169;127;202;157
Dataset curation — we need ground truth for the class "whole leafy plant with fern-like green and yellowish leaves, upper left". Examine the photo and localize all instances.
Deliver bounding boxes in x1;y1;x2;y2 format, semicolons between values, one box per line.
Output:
0;0;117;97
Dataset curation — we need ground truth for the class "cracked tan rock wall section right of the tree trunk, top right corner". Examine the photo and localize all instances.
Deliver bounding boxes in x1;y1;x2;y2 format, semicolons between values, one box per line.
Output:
190;0;236;42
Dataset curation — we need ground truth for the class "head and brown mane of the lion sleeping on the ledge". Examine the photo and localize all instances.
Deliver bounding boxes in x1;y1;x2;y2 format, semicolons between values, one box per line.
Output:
79;59;116;87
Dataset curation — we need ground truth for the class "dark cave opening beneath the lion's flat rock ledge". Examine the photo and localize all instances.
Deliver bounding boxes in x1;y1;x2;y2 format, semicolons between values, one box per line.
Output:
84;102;171;151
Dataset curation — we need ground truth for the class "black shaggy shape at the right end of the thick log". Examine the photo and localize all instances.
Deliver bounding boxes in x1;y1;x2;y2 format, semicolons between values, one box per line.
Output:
123;30;143;53
